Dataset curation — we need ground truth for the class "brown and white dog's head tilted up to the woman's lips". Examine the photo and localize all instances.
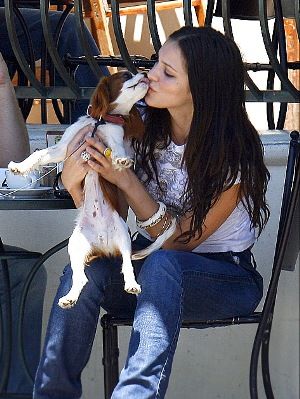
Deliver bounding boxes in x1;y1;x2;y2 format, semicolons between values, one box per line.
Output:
89;71;149;119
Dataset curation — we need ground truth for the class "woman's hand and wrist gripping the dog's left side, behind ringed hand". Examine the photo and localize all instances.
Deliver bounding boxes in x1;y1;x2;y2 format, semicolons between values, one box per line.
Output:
61;125;93;206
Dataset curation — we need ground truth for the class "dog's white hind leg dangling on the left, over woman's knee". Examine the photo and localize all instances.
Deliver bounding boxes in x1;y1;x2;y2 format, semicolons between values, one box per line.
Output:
58;227;90;309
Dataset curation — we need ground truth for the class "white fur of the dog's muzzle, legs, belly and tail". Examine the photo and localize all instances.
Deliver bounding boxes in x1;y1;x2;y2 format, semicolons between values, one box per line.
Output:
8;74;175;308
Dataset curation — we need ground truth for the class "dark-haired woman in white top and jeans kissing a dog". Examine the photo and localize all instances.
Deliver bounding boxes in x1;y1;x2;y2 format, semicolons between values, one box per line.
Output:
34;27;269;399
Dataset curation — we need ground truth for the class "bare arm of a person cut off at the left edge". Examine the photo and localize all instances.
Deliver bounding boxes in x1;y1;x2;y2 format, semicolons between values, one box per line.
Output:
0;53;30;168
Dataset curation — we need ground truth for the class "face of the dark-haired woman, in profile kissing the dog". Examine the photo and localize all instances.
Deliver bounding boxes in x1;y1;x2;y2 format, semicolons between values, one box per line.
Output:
145;40;193;111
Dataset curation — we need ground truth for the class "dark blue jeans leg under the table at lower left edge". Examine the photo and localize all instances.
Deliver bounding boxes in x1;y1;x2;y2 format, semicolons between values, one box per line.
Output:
0;245;47;393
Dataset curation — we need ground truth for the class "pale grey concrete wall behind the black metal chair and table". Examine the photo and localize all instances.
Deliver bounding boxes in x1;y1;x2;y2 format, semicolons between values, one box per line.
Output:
0;128;299;399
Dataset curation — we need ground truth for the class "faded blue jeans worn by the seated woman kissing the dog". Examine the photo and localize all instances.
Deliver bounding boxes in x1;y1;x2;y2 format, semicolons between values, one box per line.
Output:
33;238;263;399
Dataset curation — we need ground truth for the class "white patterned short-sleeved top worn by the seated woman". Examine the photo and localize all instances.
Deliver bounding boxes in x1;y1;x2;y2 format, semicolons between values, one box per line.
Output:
137;141;255;253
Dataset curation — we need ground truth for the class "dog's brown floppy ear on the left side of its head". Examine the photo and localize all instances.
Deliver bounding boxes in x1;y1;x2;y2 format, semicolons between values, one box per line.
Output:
89;77;110;119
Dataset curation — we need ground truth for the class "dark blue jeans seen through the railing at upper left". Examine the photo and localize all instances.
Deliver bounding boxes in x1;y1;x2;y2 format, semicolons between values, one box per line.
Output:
0;7;109;123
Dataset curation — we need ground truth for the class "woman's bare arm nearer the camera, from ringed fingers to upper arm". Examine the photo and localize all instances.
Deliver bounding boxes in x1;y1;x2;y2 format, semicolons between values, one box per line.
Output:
86;138;239;251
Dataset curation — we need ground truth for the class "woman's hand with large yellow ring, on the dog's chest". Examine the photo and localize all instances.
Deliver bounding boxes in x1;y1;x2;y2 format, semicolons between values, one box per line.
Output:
86;137;131;190
